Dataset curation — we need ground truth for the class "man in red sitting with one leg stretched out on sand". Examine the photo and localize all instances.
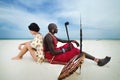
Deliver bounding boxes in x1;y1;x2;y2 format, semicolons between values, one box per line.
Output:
43;23;111;66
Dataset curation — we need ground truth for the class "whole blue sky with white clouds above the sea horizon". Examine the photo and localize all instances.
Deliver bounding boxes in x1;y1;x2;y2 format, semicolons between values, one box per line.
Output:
0;0;120;39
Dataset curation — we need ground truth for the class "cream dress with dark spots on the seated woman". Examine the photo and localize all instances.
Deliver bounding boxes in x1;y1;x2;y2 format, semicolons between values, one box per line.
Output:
31;34;44;60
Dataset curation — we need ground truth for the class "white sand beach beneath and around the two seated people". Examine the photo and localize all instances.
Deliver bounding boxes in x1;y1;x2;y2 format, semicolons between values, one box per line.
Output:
0;40;120;80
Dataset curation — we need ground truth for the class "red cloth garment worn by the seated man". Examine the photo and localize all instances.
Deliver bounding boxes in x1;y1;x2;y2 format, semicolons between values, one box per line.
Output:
45;34;80;64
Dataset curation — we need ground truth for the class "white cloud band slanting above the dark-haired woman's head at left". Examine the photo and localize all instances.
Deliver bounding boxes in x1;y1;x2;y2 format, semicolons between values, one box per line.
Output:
0;8;54;28
